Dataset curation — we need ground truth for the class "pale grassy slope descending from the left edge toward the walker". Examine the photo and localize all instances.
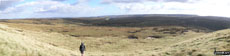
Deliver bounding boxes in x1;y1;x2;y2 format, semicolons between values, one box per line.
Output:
0;24;75;56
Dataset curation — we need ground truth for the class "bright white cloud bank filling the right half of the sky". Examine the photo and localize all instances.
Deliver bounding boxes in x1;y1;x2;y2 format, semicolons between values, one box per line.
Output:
113;0;230;17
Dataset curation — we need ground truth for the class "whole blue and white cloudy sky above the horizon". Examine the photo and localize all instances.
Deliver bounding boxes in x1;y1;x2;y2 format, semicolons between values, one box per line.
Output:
0;0;230;19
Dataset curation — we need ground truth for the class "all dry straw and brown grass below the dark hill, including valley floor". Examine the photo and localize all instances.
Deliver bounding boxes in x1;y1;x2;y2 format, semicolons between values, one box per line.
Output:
0;21;229;56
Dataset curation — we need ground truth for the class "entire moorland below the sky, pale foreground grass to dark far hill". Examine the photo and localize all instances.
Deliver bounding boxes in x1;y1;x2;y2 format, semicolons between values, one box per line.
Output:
0;14;230;56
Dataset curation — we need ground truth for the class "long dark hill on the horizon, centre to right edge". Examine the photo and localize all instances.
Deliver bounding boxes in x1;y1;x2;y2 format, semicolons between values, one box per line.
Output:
64;14;230;30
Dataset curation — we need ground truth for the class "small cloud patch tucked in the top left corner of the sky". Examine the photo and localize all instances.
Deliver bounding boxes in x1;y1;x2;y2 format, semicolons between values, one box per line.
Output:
0;0;23;10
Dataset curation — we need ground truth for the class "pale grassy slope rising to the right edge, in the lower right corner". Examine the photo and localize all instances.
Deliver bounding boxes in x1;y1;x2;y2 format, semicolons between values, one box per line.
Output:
157;29;230;56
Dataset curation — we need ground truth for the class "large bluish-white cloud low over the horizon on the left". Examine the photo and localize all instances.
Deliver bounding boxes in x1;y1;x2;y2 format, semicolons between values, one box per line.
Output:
0;1;101;18
